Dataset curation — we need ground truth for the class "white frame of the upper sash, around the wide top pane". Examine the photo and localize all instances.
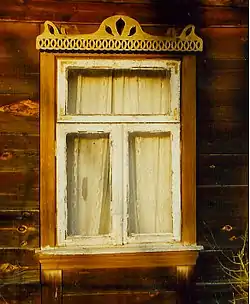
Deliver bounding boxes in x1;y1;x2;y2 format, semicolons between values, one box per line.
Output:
57;58;181;123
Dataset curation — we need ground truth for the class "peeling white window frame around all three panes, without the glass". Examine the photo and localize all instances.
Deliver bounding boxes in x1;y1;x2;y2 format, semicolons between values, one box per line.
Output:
56;58;181;251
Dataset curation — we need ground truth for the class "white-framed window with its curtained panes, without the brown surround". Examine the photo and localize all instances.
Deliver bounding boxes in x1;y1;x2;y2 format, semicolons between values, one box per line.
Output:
56;57;181;251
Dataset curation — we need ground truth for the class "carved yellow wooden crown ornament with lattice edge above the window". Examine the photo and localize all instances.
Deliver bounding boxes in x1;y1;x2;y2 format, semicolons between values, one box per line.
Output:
36;15;203;53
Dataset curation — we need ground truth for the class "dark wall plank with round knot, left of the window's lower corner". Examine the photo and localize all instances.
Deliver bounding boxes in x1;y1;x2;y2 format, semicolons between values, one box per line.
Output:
0;211;39;248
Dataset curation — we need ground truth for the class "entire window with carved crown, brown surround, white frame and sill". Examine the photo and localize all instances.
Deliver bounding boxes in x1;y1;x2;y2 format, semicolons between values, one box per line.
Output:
37;16;202;268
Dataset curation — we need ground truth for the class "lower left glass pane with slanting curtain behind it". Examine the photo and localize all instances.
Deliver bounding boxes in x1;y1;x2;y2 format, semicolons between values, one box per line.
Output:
67;134;111;236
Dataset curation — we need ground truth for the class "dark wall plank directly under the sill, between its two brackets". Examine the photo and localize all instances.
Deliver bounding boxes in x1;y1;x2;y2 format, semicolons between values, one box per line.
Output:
63;268;176;293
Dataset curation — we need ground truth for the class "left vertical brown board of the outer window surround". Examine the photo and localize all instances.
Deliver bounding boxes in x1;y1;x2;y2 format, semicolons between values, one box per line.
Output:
40;53;56;247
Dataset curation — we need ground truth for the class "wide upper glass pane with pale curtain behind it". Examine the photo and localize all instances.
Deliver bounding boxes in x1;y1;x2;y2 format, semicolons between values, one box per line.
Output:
67;69;171;115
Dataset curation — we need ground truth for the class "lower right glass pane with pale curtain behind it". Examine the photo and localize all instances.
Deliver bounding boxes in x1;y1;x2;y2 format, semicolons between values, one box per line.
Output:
128;132;172;234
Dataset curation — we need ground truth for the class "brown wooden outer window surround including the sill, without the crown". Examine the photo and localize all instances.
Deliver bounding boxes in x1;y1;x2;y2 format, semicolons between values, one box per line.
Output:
38;52;201;270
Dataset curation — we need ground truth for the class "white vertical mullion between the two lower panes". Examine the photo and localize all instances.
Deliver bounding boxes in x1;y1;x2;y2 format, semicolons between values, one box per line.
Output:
111;125;123;245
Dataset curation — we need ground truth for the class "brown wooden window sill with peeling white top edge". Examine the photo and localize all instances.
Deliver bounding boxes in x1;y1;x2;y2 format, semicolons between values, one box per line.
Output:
37;244;203;270
